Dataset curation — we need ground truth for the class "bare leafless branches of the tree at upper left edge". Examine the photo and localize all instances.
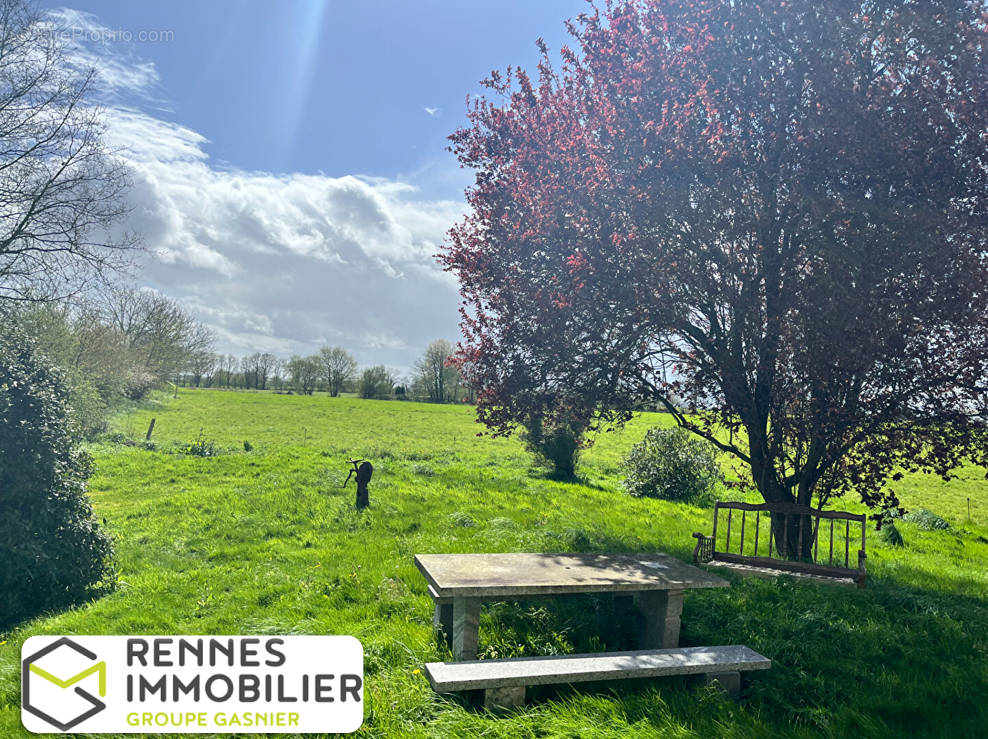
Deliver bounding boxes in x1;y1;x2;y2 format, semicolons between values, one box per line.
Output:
0;0;136;301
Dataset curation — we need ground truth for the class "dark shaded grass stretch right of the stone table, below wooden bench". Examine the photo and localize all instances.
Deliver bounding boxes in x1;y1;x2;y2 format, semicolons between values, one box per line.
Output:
682;577;988;736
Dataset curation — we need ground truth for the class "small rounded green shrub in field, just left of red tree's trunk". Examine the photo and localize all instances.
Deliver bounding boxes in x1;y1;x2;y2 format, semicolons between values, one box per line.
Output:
624;426;724;502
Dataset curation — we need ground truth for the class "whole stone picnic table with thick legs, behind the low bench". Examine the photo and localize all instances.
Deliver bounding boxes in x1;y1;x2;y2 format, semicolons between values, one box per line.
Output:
415;552;728;660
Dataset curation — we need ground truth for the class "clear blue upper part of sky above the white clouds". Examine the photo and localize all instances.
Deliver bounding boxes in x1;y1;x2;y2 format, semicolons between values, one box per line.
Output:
48;0;585;197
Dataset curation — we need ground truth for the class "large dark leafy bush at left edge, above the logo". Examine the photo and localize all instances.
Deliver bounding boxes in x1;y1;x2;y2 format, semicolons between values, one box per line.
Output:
0;332;115;627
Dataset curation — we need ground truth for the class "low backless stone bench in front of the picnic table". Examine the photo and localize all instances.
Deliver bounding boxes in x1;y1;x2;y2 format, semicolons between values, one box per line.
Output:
425;645;772;708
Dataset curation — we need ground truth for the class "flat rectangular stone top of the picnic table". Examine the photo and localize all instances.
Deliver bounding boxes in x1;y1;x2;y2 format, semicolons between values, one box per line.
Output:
415;552;728;598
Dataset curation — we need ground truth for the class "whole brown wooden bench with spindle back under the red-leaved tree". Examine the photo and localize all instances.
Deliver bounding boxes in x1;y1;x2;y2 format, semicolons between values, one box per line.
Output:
693;501;867;587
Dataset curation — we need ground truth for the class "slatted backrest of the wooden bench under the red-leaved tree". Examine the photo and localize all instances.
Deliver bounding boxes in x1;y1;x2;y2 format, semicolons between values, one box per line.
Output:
712;501;868;575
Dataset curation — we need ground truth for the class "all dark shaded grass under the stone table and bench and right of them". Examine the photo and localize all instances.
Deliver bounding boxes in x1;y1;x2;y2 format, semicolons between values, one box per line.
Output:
464;556;988;736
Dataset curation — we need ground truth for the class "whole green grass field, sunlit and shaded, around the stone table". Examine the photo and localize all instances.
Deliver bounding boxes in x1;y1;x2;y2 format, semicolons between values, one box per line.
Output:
0;391;988;737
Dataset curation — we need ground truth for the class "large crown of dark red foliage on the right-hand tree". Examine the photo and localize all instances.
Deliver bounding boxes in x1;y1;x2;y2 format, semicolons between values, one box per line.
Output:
440;0;988;516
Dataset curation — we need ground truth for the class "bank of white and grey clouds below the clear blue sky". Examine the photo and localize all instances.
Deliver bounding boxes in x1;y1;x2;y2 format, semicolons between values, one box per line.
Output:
53;9;472;369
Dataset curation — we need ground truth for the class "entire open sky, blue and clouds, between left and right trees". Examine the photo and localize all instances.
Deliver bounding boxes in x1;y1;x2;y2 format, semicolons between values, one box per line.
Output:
42;0;587;370
